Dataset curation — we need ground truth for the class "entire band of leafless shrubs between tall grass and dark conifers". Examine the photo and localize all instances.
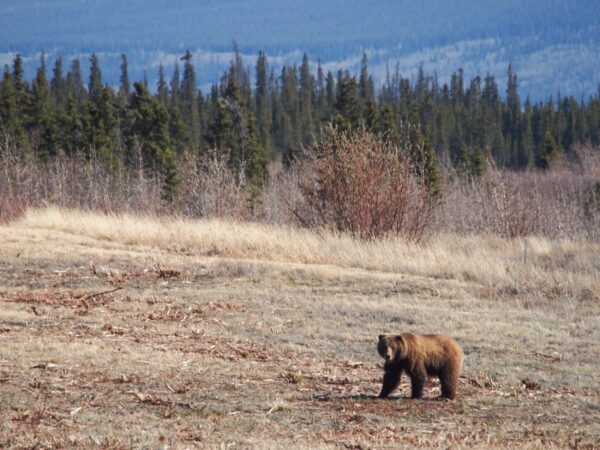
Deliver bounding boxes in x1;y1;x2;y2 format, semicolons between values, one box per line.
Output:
0;121;600;240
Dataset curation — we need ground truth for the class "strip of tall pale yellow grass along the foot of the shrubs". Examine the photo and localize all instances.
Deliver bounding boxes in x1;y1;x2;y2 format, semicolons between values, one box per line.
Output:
13;208;600;297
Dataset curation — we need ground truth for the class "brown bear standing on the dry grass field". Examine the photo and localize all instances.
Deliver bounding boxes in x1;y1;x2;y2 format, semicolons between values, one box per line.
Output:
377;333;463;399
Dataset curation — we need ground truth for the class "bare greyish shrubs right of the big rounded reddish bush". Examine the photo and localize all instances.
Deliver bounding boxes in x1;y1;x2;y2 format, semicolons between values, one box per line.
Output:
436;146;600;239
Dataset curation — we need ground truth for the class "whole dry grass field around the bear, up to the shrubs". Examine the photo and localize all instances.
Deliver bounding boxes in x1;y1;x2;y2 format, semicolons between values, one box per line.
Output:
0;209;600;449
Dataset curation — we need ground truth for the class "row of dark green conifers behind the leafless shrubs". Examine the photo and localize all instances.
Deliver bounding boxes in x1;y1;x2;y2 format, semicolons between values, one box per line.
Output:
0;48;600;199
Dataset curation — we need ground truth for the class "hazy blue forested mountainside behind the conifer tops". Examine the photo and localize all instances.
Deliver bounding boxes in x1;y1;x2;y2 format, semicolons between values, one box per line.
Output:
0;0;600;100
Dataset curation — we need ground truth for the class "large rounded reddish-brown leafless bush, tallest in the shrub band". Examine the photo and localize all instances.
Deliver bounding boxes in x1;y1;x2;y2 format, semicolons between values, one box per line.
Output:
294;127;433;241
